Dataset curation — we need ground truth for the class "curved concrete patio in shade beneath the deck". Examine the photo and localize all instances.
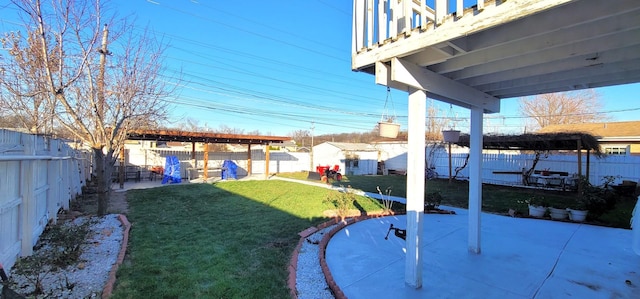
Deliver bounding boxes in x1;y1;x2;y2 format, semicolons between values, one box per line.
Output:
326;207;640;299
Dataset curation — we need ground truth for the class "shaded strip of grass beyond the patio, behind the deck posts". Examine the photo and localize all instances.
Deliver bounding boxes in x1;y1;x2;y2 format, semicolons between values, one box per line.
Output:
278;172;636;228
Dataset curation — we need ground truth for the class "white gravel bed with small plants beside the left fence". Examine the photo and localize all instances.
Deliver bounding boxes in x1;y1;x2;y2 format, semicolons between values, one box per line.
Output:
3;214;124;298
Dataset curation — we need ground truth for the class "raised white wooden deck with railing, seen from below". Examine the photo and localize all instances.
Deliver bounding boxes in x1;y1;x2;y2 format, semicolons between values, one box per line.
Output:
352;0;640;112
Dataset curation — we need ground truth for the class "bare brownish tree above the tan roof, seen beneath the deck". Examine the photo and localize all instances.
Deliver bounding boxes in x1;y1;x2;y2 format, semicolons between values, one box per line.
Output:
519;89;606;130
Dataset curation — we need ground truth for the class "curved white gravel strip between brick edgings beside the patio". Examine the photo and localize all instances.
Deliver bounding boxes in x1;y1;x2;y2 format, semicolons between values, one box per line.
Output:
296;225;336;299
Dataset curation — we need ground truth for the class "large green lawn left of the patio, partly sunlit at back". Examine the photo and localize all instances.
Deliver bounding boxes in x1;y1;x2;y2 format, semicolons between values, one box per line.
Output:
112;180;381;298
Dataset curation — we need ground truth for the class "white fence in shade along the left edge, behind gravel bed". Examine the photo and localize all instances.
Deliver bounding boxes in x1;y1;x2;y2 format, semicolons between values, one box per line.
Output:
0;129;91;269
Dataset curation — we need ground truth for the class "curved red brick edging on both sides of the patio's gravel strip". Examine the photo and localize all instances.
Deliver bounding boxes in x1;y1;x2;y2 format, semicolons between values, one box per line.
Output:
287;213;398;299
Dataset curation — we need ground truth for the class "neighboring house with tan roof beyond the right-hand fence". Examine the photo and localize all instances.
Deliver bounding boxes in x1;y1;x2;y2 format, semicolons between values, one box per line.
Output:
538;121;640;155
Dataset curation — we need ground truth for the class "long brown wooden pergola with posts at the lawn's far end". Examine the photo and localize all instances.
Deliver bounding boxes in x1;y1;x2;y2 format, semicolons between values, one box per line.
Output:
125;130;291;180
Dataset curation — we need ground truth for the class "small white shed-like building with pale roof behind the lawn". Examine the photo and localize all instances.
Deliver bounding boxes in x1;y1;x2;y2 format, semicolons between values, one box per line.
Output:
313;142;379;175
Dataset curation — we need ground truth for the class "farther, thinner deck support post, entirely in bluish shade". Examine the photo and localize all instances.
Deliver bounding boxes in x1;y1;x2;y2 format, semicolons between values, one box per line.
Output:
469;107;483;254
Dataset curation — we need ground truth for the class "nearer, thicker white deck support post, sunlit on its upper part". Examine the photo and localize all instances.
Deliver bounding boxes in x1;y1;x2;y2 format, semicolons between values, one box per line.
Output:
404;88;427;289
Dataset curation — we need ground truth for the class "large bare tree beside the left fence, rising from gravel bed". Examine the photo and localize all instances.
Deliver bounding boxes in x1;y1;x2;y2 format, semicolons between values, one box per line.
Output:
0;0;173;215
